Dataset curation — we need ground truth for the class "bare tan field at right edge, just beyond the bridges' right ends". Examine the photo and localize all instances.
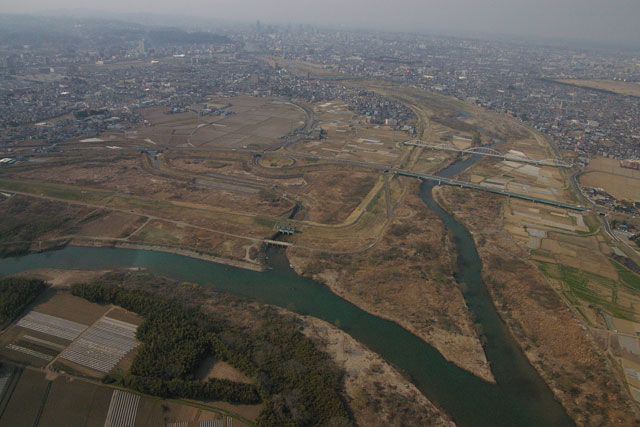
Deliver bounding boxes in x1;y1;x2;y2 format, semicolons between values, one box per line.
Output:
580;157;640;201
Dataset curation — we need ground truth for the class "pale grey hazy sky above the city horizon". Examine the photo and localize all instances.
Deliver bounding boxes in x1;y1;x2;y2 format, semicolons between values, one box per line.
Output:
0;0;640;44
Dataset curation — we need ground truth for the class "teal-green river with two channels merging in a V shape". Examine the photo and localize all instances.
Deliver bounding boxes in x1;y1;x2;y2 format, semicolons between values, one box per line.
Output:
0;153;573;426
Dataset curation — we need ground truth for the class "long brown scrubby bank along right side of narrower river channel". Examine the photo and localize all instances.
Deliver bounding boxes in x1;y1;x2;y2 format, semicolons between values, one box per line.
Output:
434;187;640;425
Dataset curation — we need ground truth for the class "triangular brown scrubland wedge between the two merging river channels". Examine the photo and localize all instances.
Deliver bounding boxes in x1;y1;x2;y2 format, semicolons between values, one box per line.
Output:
287;181;495;383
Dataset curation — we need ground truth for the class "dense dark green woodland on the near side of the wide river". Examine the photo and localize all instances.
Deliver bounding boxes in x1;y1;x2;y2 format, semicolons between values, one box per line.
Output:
71;273;352;426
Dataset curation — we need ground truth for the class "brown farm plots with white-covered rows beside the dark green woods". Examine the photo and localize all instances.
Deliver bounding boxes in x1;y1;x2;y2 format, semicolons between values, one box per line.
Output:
0;275;257;426
